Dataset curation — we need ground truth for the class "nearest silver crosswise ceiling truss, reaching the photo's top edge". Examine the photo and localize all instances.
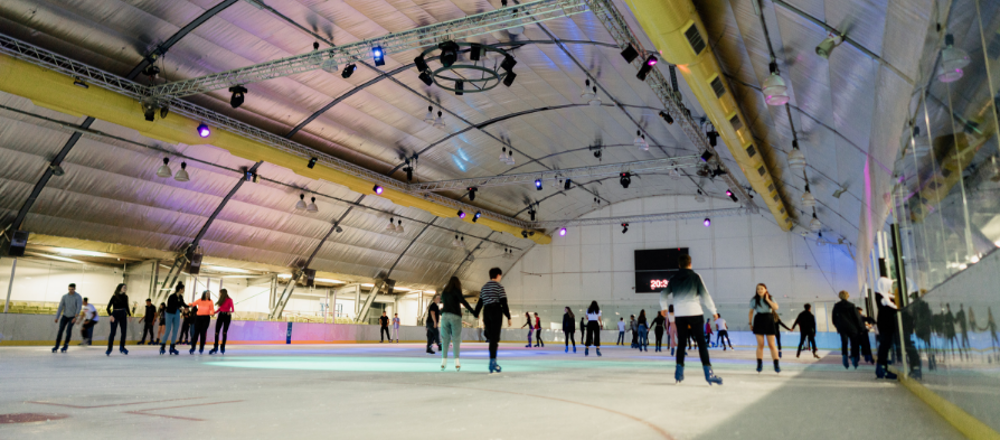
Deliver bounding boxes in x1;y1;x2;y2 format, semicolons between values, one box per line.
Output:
150;0;587;102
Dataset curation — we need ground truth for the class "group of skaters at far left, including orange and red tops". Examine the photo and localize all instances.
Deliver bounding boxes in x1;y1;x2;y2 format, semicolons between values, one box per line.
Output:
52;282;236;356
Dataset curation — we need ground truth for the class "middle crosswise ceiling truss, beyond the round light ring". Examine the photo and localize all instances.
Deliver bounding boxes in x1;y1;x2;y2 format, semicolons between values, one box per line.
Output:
410;156;704;192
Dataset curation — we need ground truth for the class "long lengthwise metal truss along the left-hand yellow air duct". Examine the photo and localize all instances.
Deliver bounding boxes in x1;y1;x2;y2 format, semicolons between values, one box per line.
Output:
0;34;531;229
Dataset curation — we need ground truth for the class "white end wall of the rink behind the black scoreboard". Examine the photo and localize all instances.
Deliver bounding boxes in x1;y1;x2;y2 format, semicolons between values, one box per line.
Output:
503;196;857;328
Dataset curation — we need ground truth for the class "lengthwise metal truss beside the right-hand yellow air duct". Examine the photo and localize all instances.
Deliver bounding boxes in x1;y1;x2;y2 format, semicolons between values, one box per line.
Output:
586;0;759;213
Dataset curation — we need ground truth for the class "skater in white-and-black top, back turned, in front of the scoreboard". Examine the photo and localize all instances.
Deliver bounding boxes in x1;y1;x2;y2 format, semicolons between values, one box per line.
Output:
660;255;722;385
